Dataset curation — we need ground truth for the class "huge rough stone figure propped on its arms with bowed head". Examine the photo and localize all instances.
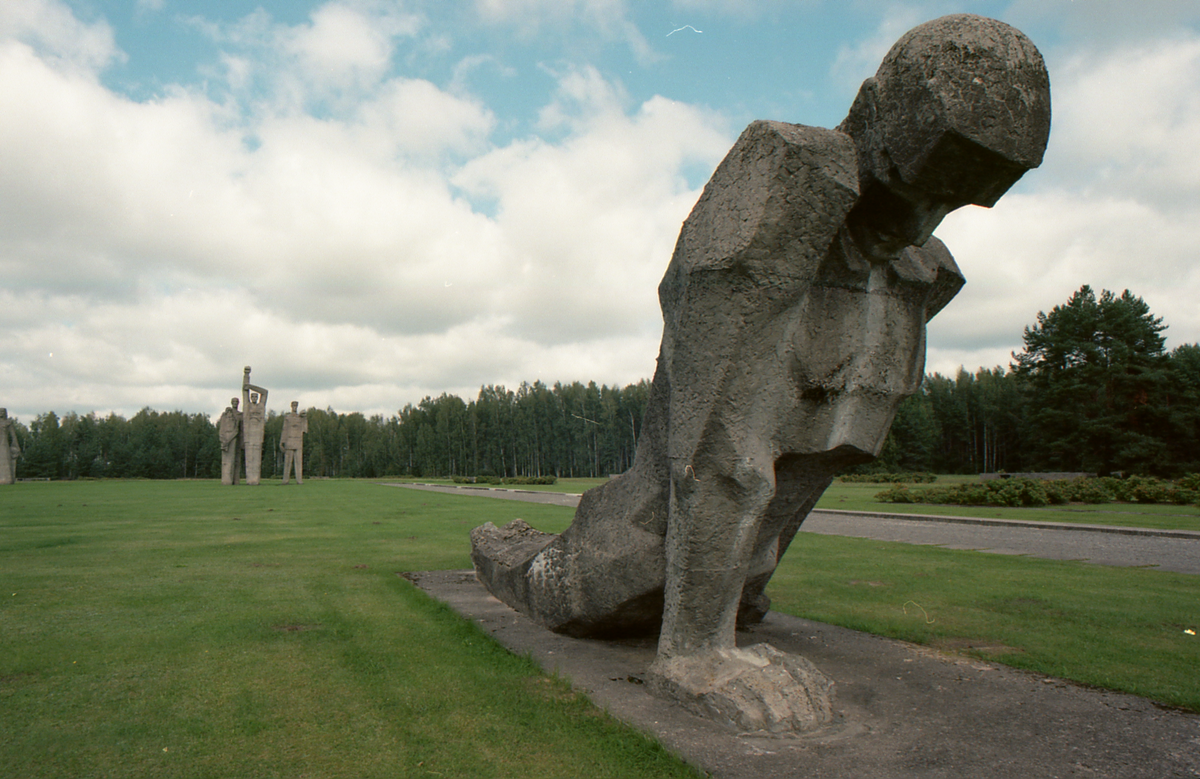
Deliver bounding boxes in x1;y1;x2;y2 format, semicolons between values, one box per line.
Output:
472;14;1050;731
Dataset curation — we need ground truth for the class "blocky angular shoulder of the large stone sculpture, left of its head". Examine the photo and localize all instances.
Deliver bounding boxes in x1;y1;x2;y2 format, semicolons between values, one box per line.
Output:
676;121;858;275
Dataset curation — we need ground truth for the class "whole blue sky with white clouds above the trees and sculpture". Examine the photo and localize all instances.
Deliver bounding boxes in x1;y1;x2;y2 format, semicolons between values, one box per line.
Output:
0;0;1200;423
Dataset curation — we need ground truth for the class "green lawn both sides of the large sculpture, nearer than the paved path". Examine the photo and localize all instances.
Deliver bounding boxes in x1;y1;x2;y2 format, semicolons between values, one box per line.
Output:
0;472;1200;778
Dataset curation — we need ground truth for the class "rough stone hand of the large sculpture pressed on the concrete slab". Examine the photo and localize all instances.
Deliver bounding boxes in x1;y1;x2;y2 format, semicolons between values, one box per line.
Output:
647;643;834;733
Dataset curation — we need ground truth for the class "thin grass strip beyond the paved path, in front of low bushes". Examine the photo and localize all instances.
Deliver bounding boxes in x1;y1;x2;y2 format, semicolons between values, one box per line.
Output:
817;477;1200;531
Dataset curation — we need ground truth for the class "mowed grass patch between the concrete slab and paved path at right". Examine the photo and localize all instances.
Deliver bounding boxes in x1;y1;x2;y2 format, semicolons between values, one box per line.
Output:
767;533;1200;712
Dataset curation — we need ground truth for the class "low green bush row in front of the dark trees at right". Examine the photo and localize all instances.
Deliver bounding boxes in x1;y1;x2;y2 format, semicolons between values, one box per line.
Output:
875;473;1200;507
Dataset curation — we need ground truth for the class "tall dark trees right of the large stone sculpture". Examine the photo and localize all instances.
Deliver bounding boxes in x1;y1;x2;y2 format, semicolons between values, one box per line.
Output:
874;286;1200;477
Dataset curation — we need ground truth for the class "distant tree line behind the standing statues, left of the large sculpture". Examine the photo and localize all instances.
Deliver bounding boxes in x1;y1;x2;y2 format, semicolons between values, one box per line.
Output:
4;380;649;479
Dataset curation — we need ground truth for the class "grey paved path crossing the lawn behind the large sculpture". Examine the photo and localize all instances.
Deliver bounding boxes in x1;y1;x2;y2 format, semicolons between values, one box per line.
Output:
390;484;1200;574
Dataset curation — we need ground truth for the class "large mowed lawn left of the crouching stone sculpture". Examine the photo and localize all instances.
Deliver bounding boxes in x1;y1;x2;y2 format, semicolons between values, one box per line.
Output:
0;480;697;778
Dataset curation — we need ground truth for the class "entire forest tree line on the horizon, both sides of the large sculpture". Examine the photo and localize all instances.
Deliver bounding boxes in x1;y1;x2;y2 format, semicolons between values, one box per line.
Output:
16;286;1200;479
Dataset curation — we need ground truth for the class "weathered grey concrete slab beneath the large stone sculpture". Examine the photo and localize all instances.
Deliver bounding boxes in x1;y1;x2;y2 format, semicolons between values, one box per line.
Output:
407;571;1200;779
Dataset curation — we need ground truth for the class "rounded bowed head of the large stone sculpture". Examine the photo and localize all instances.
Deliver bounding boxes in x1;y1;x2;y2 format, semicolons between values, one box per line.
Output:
839;14;1050;260
